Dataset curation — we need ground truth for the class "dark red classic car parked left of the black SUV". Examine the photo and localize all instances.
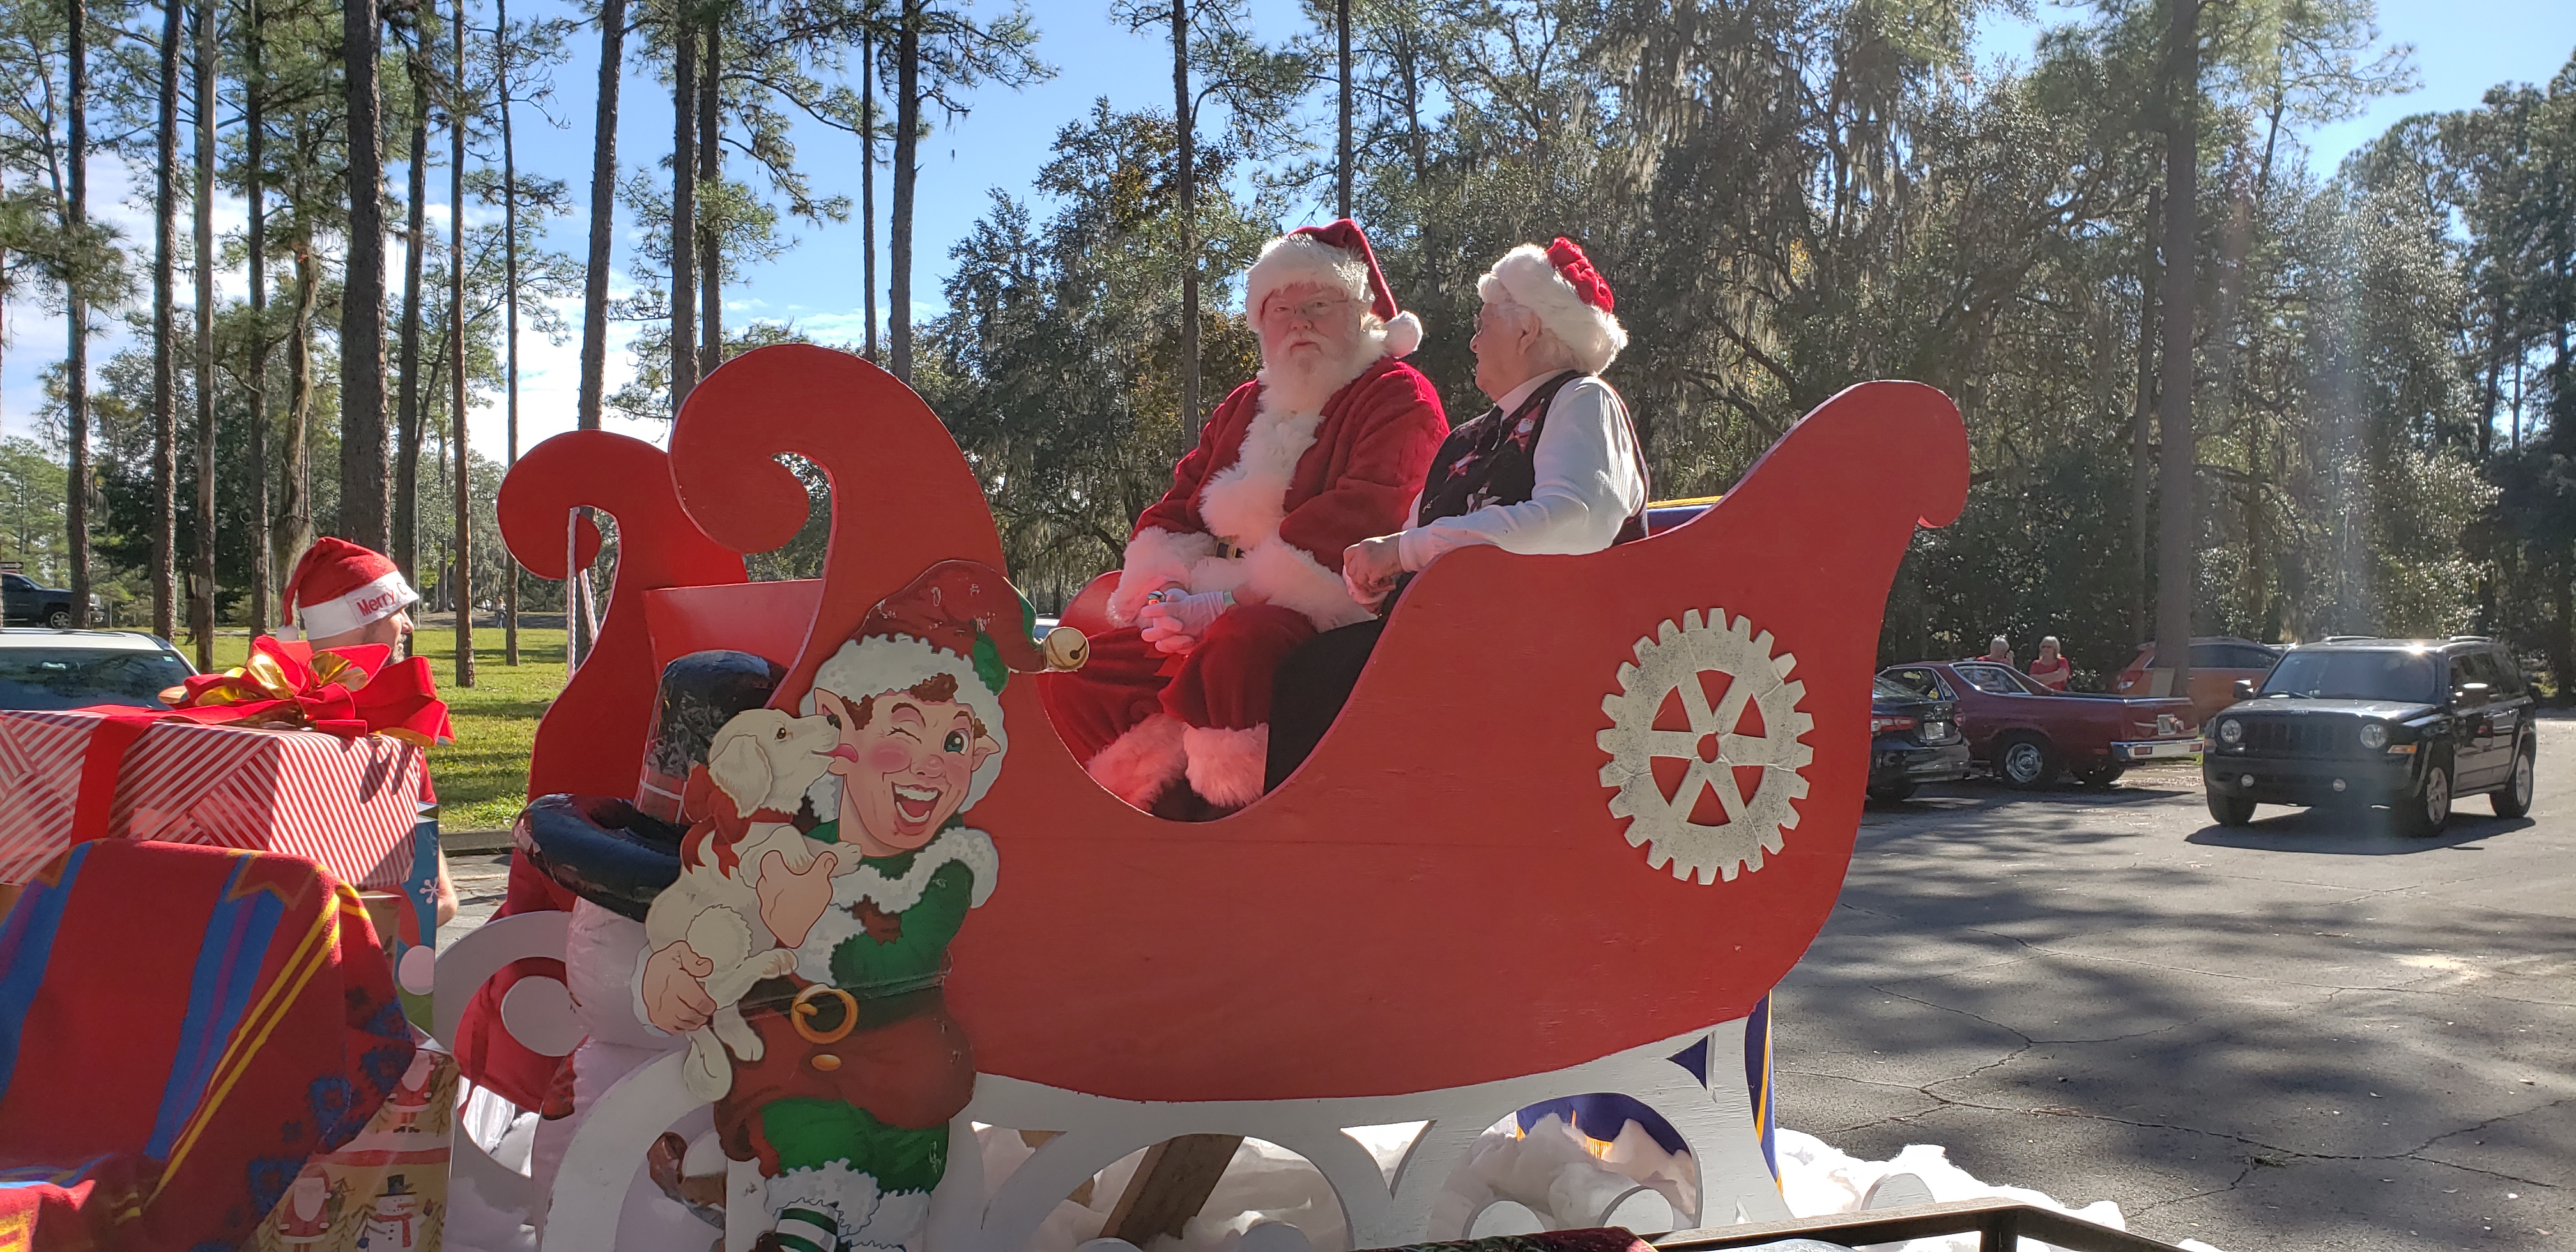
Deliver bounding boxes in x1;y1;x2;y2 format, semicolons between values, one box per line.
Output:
1878;662;2200;788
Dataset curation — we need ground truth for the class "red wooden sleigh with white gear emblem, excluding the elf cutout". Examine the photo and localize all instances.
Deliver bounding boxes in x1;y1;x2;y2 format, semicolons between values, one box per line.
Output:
443;347;1968;1249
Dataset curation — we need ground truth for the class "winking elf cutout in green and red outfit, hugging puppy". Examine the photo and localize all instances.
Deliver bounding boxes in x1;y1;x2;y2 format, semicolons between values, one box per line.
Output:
641;561;1082;1252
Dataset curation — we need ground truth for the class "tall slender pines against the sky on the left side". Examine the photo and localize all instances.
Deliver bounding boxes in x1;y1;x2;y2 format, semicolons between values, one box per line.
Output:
0;0;1048;685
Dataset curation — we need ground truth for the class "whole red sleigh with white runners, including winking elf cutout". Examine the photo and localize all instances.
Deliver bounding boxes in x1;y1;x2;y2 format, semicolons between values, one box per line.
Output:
438;345;1968;1252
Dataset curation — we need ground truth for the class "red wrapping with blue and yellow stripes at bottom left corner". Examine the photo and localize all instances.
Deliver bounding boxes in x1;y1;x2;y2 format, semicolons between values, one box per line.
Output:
0;840;412;1252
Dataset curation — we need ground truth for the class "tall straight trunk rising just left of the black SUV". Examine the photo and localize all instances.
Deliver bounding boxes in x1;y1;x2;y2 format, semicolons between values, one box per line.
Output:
2156;0;2200;696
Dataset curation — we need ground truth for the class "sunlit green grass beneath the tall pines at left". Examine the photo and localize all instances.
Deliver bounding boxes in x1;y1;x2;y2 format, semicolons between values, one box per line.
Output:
211;623;564;835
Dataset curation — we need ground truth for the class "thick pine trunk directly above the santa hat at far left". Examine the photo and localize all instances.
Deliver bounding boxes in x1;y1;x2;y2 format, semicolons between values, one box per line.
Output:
337;0;392;551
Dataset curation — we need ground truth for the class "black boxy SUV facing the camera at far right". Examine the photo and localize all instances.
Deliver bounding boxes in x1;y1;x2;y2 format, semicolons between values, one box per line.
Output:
2200;636;2534;835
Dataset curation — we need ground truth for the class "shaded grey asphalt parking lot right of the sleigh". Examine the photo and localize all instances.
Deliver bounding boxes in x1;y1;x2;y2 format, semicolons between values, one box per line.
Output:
1775;716;2576;1252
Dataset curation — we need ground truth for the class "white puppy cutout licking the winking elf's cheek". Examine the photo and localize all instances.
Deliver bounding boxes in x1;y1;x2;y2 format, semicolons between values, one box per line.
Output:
636;708;839;1100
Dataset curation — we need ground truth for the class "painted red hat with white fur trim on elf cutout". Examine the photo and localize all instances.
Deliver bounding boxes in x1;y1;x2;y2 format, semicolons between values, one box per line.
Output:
801;561;1090;806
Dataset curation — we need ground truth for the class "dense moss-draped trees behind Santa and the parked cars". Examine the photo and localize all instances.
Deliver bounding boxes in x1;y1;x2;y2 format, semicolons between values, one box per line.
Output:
914;0;2576;691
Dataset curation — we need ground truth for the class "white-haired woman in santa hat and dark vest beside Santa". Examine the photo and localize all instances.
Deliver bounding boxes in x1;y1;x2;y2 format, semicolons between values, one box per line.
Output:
1265;237;1646;786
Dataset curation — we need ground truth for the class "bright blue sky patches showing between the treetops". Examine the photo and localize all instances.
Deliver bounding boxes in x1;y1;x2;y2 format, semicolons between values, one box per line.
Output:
0;0;2576;459
